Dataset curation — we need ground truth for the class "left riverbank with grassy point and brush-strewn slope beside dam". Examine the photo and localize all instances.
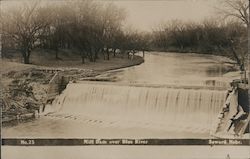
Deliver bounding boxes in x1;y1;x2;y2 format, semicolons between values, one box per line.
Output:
0;56;144;126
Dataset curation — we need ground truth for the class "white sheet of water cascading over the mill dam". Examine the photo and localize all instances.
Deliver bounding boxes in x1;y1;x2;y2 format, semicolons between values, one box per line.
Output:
49;82;226;133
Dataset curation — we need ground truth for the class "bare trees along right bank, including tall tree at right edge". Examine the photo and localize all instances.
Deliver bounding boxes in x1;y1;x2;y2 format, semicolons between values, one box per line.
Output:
151;0;250;71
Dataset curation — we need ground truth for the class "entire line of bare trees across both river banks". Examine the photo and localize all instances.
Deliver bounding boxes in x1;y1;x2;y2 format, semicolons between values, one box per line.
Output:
1;0;249;70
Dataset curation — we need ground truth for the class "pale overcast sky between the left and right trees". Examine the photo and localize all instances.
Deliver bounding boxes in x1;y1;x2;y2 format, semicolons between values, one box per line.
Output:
113;0;218;31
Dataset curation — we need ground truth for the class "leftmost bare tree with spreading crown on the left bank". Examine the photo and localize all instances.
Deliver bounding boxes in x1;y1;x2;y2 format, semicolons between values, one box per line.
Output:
1;1;50;64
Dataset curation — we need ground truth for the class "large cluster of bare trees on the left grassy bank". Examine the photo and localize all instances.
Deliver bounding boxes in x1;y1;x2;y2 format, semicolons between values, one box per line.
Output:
1;0;145;64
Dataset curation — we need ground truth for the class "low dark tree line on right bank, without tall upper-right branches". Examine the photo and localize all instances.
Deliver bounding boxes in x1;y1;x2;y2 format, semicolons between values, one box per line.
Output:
152;20;248;70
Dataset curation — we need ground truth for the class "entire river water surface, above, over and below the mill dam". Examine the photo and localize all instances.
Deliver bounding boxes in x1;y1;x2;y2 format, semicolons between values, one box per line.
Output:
2;53;236;138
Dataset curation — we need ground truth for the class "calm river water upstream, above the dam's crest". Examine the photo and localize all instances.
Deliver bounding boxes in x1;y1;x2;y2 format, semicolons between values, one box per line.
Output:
101;52;236;86
